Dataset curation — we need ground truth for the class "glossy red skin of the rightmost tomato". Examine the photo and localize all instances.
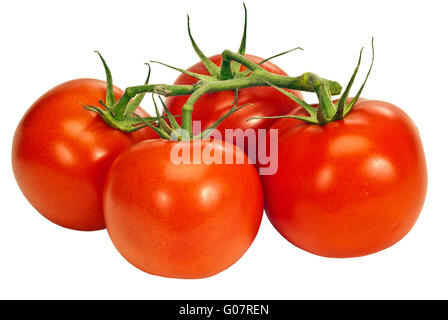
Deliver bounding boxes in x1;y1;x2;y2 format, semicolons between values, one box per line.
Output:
262;100;427;258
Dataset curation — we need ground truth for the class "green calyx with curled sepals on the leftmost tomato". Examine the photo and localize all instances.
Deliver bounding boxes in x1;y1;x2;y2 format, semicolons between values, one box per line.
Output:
83;51;157;132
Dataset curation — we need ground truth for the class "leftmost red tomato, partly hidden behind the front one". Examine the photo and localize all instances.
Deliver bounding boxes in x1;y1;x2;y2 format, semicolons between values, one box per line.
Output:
12;79;157;230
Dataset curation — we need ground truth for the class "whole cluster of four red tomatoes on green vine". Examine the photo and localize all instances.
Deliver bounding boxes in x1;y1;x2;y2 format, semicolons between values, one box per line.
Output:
12;7;427;278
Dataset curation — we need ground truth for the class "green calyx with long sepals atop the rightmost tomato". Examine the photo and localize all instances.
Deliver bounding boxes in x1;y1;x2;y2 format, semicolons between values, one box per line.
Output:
247;38;375;125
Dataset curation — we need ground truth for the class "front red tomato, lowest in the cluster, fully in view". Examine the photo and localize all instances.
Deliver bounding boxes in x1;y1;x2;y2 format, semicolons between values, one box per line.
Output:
103;139;263;278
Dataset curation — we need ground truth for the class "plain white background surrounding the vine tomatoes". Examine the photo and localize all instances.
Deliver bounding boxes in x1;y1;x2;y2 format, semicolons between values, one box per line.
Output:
0;0;448;299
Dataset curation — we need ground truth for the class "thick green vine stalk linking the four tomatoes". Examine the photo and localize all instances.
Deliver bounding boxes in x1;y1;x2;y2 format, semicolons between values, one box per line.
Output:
93;50;341;138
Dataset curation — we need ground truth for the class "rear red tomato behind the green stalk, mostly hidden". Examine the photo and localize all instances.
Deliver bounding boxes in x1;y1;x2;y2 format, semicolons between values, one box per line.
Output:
166;54;302;139
